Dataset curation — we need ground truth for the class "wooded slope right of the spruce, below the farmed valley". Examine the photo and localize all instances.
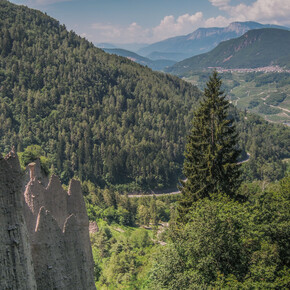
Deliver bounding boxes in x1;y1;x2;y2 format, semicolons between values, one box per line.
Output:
230;111;290;181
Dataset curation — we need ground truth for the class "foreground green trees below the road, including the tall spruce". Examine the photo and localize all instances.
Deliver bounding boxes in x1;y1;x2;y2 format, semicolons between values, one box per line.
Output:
85;76;290;290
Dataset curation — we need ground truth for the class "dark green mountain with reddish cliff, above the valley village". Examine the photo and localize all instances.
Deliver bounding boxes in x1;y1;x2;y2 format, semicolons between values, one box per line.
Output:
167;28;290;75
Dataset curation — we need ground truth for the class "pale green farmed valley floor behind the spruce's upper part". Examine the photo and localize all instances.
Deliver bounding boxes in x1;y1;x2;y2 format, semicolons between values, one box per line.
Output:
187;72;290;123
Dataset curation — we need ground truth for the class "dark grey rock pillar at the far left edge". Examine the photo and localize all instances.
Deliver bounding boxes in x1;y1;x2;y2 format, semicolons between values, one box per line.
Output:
0;152;36;290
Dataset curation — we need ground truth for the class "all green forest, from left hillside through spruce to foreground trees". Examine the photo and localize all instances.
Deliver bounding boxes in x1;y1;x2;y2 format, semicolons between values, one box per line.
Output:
0;0;290;290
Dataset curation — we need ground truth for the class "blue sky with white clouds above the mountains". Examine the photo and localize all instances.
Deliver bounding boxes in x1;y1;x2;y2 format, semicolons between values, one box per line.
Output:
10;0;290;44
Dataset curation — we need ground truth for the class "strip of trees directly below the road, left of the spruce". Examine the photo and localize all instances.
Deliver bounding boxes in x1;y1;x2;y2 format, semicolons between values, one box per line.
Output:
82;181;178;227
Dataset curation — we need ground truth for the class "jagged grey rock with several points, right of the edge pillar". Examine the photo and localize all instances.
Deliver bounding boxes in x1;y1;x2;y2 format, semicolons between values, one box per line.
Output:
23;162;96;290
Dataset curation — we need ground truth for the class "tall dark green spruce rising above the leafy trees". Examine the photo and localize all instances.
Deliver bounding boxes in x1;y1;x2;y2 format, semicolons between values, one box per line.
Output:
178;71;240;221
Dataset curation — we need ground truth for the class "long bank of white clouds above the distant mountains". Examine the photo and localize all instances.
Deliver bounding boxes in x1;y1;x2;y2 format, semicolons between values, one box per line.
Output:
89;0;290;43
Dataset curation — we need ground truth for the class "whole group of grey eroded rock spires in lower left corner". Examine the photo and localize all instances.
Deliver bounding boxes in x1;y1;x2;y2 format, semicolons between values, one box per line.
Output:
0;152;95;290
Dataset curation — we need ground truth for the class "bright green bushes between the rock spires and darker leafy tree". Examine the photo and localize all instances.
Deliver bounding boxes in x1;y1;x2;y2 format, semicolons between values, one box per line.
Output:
91;223;154;289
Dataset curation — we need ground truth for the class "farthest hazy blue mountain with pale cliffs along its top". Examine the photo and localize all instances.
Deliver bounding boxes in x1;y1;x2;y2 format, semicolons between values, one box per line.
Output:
137;22;289;61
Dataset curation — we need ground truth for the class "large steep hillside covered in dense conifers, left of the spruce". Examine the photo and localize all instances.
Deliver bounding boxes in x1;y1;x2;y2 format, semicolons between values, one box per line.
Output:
0;1;200;187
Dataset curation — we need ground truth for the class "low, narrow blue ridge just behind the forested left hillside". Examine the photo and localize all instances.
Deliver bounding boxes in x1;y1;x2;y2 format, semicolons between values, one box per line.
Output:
103;48;176;71
